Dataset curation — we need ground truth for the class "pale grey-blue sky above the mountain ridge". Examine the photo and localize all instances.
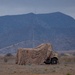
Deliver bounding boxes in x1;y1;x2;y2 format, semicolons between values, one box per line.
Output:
0;0;75;18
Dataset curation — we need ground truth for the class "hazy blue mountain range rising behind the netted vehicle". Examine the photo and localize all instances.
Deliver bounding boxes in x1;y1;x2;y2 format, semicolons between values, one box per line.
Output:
0;12;75;53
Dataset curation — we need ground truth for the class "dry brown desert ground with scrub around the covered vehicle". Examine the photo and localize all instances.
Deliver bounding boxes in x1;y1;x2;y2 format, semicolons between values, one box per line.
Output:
0;52;75;75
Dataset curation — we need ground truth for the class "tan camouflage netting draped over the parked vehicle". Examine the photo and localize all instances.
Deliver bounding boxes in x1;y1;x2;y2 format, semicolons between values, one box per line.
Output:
16;43;52;65
